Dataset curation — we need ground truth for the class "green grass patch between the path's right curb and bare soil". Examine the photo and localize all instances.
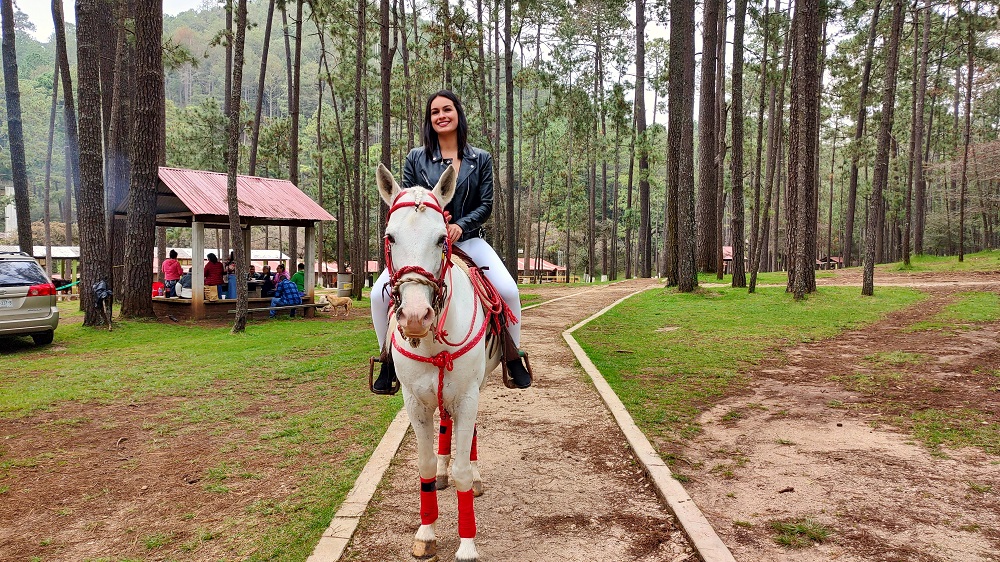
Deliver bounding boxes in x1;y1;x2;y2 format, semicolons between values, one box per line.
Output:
576;287;925;441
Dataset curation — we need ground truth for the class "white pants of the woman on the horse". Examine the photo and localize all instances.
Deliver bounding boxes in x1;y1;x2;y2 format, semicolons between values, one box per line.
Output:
371;238;521;349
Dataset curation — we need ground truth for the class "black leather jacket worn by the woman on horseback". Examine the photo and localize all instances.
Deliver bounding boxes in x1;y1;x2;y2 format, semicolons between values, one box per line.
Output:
403;145;493;241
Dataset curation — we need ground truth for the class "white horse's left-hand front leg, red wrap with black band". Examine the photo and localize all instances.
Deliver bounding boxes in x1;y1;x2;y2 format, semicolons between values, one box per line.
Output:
404;396;438;559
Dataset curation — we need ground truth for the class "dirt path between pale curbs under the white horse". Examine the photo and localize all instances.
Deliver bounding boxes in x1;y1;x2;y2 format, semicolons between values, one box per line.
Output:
344;280;694;562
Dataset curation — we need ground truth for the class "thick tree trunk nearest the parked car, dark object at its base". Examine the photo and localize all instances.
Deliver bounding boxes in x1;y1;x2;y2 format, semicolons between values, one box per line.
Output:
75;0;111;326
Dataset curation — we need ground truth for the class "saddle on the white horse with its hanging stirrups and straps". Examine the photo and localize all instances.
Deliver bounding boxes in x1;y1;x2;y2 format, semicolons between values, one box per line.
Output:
368;247;534;394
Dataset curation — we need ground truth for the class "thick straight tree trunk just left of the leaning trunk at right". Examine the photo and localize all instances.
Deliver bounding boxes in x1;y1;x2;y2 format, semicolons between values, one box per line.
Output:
787;0;822;299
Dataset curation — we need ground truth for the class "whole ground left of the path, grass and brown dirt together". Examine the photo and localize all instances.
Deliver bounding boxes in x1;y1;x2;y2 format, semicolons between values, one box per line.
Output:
0;303;402;560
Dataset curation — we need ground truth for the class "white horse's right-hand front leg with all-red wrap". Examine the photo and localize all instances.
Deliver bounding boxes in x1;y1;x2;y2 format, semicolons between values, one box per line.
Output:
451;389;479;562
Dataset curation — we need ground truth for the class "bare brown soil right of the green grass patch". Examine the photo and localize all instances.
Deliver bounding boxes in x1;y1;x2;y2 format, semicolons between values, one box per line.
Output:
675;270;1000;562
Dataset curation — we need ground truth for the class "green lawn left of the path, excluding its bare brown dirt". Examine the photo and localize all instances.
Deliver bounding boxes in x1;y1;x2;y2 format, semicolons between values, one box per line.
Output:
0;300;402;560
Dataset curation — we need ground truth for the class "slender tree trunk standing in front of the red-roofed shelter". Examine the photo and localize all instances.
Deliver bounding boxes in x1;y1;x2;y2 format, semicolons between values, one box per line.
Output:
226;0;250;328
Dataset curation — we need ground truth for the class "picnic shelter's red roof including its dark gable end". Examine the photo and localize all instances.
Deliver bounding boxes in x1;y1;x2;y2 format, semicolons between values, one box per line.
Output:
115;167;335;226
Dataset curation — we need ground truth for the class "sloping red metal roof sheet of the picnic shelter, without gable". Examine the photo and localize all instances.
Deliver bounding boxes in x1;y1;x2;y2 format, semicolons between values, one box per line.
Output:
159;168;335;221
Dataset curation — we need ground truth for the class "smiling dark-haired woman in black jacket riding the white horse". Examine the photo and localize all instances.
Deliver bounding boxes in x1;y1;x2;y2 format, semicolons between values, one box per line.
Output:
371;90;531;394
